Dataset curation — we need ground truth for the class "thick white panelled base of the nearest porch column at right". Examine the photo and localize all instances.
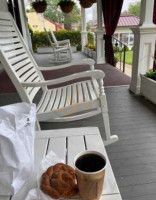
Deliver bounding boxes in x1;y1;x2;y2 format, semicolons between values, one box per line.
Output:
130;25;156;94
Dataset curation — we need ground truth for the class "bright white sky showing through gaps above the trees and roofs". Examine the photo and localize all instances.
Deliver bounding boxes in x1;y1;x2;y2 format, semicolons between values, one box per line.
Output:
24;0;140;21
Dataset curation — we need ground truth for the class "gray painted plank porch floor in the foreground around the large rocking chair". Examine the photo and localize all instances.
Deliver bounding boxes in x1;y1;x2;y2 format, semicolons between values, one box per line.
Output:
0;86;156;200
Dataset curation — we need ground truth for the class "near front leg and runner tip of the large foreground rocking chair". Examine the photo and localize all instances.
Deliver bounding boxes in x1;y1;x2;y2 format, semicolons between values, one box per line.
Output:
100;95;118;146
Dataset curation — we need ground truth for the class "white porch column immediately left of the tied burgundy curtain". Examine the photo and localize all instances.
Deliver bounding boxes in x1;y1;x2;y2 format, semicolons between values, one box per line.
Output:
95;0;105;64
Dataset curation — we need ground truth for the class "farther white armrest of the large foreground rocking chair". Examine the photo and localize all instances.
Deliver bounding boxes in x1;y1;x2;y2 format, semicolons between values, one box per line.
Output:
38;59;95;71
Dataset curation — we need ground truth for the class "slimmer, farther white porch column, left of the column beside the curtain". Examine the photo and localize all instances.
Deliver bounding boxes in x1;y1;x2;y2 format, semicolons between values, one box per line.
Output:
81;7;88;52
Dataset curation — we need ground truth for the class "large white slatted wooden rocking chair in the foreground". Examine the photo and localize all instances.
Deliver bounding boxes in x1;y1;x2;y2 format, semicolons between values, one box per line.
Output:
0;12;118;145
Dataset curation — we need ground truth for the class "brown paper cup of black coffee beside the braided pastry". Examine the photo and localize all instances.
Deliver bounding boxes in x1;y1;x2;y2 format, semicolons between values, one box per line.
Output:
74;151;106;200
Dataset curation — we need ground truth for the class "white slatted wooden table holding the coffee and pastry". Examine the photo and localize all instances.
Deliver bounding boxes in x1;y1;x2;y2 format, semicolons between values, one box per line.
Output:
0;127;122;200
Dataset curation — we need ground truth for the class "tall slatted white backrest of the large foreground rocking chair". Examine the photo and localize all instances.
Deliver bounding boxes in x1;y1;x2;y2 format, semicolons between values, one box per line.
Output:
0;12;47;103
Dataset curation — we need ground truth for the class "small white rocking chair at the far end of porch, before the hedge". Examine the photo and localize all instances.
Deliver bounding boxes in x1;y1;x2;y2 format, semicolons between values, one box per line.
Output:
44;28;72;62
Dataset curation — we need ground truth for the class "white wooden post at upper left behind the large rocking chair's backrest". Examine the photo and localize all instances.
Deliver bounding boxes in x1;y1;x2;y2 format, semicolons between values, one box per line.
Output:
18;0;32;51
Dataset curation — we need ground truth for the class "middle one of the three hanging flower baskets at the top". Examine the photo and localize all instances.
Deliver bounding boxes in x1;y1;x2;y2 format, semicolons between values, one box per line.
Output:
58;0;75;13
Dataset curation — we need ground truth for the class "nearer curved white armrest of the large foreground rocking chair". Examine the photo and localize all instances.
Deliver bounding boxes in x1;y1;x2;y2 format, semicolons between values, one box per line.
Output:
21;70;105;87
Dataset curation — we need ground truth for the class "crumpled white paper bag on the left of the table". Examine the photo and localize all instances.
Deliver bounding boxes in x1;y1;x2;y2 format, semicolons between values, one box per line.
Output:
0;103;36;195
